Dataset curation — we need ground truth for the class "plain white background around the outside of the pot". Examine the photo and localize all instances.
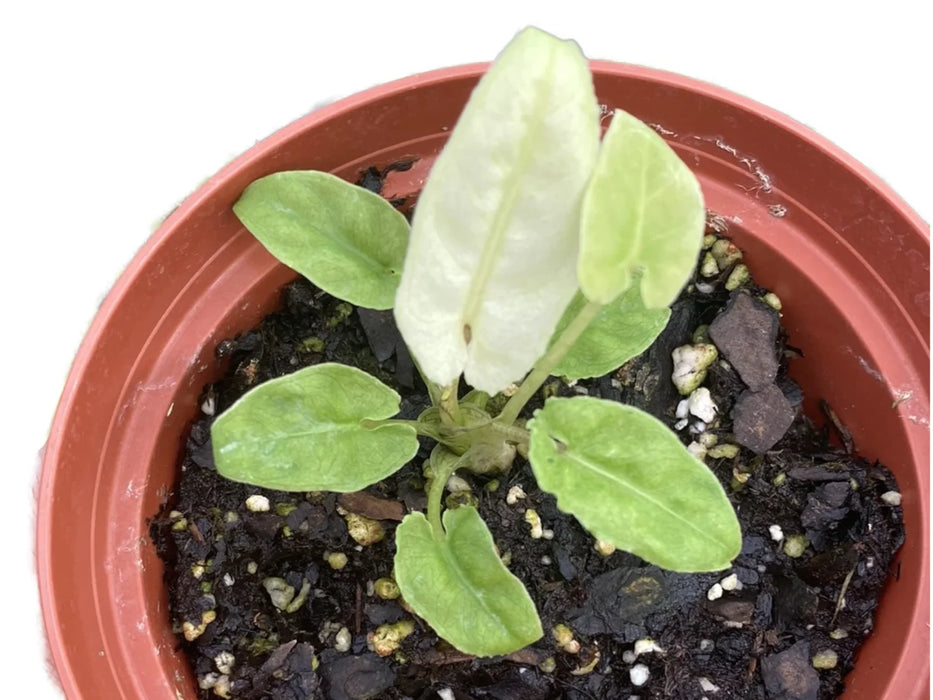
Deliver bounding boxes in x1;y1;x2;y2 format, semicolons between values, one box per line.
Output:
0;0;933;700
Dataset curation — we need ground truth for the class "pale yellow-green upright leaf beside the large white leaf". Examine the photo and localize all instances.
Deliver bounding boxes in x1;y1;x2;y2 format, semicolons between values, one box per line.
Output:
578;109;706;309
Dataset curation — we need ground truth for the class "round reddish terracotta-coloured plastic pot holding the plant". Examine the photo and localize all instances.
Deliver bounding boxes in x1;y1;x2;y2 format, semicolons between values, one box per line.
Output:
36;62;930;700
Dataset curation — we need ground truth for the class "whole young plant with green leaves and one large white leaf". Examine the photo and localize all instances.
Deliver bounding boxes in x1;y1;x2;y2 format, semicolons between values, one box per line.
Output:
212;28;741;656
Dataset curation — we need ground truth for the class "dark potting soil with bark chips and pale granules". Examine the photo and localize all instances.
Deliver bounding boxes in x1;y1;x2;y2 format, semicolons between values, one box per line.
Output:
151;209;903;700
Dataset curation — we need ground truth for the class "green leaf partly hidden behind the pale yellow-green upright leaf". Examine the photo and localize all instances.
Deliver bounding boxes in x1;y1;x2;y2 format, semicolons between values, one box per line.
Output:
551;286;671;379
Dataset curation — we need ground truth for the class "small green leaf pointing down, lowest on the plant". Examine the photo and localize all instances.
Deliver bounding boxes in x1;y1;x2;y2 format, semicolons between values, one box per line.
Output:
395;506;542;656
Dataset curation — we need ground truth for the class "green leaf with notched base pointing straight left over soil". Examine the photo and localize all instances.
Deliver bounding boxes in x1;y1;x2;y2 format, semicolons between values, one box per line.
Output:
211;364;418;492
